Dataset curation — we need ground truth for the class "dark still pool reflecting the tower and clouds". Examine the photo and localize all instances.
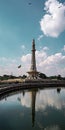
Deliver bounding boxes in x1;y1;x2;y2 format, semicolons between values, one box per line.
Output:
0;88;65;130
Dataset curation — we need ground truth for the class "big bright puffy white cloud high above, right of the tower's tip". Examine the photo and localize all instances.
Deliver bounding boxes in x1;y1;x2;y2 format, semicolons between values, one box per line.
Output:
40;0;65;37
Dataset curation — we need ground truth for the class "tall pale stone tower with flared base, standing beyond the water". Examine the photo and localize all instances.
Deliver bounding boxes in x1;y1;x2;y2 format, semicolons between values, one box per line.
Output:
27;39;39;79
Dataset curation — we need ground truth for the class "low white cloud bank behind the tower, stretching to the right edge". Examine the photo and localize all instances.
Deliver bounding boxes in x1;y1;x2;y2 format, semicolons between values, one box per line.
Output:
21;47;65;76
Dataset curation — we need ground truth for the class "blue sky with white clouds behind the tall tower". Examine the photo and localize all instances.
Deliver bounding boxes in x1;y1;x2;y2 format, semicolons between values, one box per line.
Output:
0;0;65;76
